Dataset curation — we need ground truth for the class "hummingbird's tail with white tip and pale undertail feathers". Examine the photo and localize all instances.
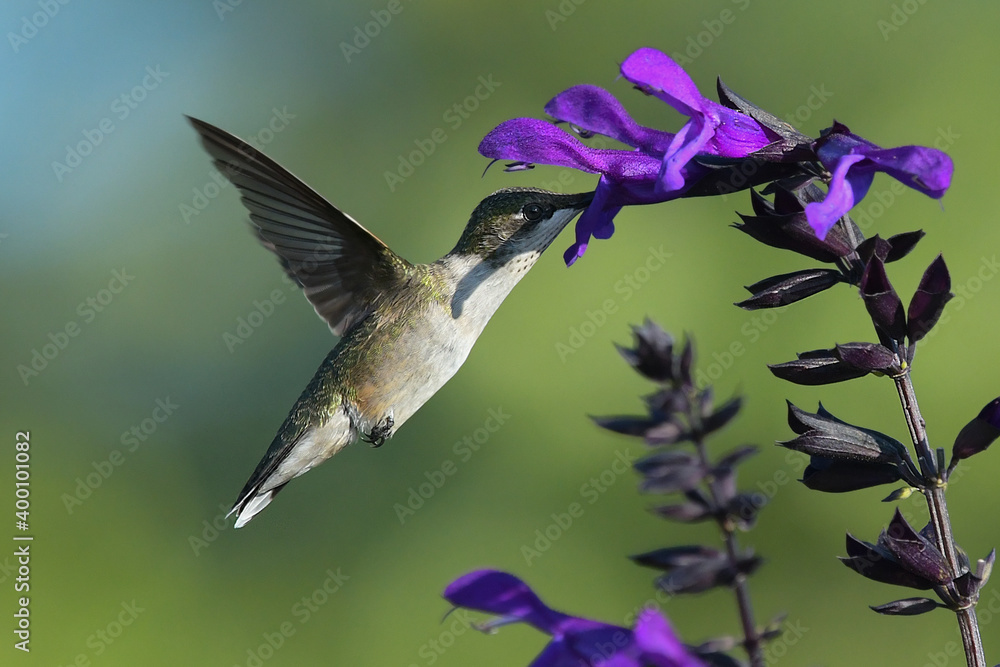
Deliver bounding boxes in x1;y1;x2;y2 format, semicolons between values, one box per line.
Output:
227;406;358;528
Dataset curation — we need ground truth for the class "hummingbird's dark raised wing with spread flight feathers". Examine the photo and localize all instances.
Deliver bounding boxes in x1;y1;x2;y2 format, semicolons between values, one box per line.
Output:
187;116;412;336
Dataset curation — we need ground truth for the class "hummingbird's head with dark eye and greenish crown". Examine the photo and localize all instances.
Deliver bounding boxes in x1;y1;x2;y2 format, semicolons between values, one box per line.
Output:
451;188;594;271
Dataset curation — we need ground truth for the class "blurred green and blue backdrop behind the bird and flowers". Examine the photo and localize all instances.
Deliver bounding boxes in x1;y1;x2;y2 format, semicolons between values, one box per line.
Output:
0;0;1000;667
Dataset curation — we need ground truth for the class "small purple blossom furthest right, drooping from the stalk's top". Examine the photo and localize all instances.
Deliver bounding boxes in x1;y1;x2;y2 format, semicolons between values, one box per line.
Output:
806;123;954;239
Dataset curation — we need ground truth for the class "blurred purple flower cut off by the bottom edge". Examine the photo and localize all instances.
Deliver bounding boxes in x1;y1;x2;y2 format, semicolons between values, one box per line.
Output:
444;570;702;667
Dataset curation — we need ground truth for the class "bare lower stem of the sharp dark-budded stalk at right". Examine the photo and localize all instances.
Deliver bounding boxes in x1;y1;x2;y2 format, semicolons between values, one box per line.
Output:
893;370;986;667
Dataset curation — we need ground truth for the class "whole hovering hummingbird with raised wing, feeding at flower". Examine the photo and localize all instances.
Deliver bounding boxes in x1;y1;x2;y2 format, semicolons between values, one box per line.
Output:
188;117;594;528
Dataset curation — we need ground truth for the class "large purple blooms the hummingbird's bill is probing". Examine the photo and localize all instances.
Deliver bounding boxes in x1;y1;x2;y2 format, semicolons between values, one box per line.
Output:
479;48;778;264
